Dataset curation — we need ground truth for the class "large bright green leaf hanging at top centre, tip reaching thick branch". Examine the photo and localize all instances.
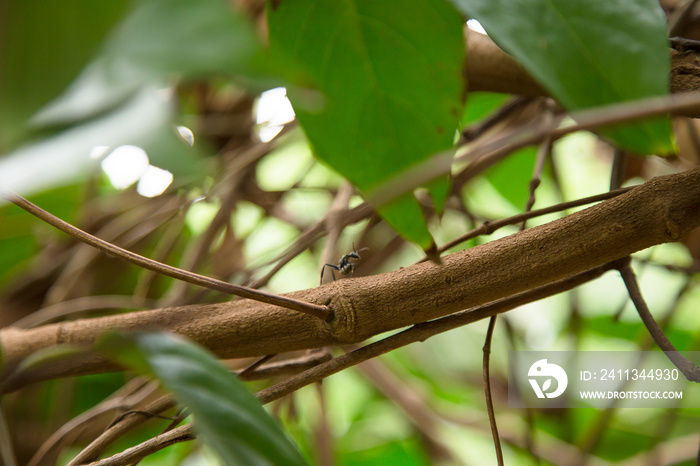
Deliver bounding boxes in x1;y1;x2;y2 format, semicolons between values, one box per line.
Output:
268;0;465;249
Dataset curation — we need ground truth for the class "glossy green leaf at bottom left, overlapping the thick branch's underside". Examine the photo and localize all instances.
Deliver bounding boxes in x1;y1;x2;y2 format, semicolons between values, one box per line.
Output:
98;332;306;465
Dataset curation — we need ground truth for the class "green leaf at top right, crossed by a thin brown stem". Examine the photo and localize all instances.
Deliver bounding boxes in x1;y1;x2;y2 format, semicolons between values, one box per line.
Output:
451;0;674;155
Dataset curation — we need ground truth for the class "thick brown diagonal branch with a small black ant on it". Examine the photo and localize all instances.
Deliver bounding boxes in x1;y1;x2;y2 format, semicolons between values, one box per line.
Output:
0;168;700;390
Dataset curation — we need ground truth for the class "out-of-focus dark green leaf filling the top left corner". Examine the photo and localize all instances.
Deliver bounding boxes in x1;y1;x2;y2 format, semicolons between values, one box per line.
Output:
0;0;129;149
